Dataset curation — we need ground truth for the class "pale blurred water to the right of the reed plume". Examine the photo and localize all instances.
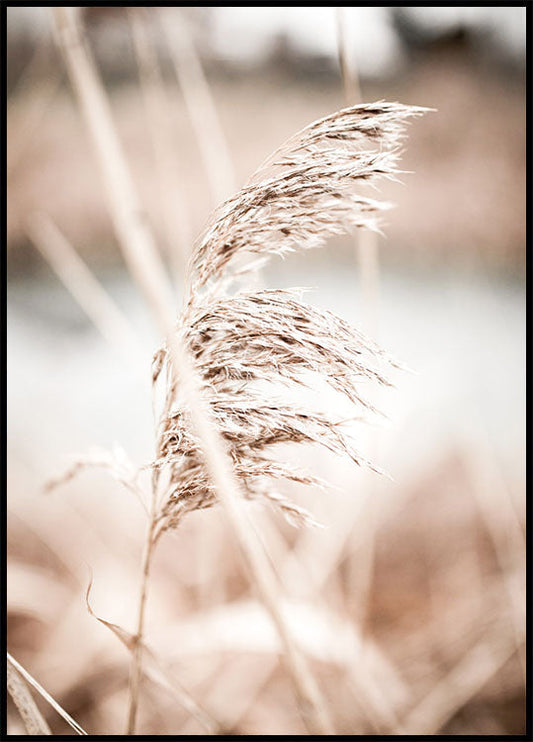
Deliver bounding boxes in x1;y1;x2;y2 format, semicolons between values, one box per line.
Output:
270;258;525;486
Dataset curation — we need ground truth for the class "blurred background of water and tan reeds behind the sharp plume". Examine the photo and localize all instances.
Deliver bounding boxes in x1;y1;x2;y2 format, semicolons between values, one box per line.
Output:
7;6;526;735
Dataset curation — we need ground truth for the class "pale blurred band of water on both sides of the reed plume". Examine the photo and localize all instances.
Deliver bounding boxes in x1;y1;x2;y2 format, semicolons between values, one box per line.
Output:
8;260;525;488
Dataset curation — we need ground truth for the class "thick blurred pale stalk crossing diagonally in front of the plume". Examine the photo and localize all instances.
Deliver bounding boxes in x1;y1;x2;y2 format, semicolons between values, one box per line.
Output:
53;7;332;734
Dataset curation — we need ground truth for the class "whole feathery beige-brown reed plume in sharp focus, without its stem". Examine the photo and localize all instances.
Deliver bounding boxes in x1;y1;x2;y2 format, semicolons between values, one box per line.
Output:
153;102;425;539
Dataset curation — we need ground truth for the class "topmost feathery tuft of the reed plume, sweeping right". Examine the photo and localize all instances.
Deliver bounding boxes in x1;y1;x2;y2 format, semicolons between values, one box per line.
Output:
189;102;426;304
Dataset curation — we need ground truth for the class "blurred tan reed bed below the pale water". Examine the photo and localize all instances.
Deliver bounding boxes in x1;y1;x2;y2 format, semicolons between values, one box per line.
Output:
8;440;525;735
